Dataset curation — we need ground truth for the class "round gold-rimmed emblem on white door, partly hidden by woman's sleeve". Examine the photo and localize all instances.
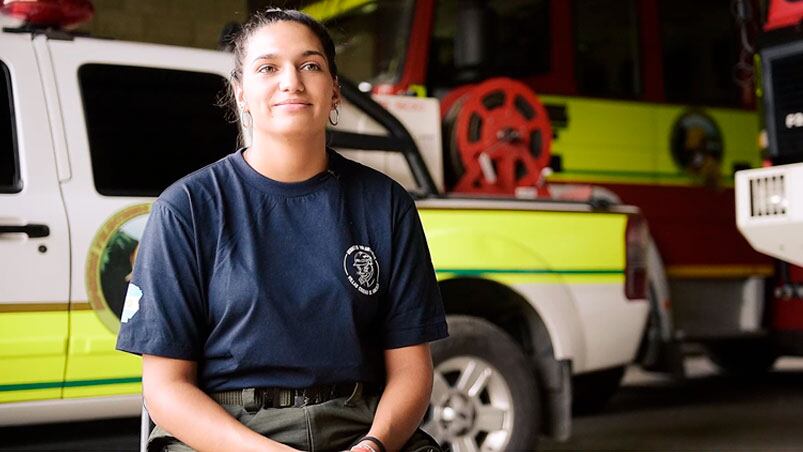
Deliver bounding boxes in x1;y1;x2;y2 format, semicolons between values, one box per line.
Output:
86;203;151;334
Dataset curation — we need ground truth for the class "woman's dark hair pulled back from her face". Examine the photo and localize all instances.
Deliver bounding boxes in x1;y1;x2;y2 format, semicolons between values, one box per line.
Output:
219;8;337;138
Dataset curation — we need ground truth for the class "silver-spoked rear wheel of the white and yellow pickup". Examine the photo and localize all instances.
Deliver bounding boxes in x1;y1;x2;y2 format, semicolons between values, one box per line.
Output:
423;316;540;452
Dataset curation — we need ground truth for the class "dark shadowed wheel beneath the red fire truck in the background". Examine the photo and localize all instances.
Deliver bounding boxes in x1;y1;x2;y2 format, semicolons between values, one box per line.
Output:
706;339;778;376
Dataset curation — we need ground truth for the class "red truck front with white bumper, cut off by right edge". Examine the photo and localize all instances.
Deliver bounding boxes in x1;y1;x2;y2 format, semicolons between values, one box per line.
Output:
736;0;803;355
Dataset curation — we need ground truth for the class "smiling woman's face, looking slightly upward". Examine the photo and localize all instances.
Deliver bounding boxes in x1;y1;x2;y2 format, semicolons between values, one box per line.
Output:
235;21;340;137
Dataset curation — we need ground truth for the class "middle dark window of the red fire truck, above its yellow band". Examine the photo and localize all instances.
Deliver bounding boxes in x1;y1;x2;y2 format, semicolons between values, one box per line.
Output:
574;0;641;99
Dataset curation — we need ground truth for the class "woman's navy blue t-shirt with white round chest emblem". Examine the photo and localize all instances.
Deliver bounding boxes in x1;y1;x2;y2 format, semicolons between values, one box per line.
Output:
117;150;447;392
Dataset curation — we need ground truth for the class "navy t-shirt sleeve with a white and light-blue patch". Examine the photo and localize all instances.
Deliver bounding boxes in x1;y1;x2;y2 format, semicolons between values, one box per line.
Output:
117;200;205;360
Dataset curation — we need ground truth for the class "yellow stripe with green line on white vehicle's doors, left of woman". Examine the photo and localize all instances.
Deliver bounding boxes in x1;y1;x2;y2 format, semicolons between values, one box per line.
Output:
0;303;142;402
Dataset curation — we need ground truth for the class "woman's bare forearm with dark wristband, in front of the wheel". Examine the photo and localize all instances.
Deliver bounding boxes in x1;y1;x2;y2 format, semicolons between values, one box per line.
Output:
360;343;432;451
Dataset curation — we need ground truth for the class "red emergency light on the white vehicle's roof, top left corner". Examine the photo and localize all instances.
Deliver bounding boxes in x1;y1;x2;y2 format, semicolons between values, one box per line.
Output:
0;0;95;28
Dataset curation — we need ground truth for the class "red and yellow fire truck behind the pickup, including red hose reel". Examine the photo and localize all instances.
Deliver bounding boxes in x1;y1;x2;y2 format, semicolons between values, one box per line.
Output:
305;0;776;374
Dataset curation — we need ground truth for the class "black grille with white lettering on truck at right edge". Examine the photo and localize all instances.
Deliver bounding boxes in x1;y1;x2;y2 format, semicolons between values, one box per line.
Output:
763;42;803;164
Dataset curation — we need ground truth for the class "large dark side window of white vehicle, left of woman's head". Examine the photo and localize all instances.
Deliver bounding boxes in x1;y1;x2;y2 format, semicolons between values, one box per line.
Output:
78;64;238;196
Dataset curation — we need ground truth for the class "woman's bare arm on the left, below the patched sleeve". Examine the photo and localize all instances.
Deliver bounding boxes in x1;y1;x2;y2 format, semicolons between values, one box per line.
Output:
142;355;294;451
